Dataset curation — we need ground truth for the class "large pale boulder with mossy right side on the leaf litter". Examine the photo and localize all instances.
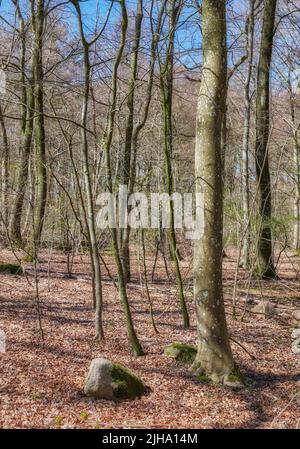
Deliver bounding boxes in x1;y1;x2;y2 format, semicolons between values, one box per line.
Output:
84;358;146;401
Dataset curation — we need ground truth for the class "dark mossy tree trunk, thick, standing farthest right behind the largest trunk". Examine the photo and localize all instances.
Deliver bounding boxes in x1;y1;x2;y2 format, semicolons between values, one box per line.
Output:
255;0;277;278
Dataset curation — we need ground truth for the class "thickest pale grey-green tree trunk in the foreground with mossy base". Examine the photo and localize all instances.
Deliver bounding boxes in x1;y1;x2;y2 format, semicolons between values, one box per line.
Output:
192;0;241;384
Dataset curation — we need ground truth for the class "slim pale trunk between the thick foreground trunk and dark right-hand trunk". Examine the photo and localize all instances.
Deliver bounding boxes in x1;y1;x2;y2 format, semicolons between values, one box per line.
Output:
241;0;255;268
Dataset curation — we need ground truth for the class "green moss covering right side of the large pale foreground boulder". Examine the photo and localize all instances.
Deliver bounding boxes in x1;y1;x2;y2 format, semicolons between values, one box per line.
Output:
110;363;145;400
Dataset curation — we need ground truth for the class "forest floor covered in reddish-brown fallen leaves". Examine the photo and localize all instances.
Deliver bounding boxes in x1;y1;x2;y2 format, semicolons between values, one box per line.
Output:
0;250;300;428
